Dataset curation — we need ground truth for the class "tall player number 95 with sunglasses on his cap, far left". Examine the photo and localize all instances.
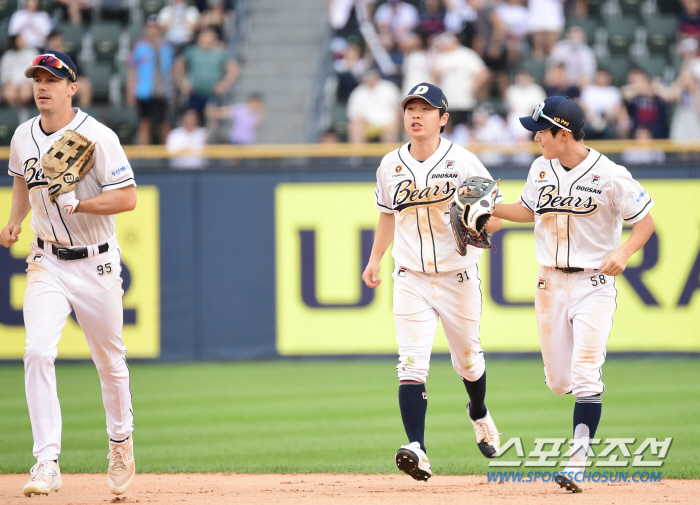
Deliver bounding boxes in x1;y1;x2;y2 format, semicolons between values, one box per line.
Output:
0;51;136;496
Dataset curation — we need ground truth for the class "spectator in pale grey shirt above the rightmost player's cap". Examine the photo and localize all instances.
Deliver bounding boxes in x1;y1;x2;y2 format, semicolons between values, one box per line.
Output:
547;25;596;87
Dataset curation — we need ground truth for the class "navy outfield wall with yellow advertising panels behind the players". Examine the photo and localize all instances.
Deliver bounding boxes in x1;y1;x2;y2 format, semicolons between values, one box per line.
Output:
0;161;700;360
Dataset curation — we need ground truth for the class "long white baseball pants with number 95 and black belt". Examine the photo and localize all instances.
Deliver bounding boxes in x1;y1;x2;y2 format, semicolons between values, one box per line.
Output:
24;237;133;461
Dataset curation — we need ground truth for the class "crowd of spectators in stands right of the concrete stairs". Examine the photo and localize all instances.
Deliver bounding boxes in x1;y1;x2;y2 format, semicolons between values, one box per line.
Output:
326;0;700;159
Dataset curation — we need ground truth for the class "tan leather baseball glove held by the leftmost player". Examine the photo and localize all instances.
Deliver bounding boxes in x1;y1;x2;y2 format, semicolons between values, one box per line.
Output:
41;130;95;201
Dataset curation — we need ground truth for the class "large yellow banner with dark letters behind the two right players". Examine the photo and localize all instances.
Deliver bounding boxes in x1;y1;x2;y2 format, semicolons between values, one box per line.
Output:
275;179;700;355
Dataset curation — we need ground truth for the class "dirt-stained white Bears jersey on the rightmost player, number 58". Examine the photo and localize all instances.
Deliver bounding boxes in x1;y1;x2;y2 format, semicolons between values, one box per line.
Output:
520;149;654;268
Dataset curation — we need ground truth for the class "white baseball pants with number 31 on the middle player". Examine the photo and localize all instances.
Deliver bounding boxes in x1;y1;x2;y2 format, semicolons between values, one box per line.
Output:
393;265;485;382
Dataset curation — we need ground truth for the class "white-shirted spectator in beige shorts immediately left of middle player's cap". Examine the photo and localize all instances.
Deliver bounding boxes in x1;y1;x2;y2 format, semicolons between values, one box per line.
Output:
347;70;401;144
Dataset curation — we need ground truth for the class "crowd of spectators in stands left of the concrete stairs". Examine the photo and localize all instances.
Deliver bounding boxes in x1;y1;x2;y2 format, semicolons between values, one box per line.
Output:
0;0;265;163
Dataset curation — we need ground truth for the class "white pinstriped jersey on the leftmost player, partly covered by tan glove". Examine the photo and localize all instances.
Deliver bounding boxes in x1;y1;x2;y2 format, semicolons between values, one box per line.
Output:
9;107;135;246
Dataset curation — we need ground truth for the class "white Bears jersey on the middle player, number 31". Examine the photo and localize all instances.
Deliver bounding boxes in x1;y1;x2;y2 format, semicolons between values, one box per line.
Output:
375;138;503;273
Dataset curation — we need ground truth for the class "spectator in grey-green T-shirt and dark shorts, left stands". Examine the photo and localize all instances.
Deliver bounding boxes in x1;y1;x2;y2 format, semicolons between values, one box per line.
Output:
174;28;238;121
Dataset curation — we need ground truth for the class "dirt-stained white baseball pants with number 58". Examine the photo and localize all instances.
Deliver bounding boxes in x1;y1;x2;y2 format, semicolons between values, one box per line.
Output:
535;267;617;397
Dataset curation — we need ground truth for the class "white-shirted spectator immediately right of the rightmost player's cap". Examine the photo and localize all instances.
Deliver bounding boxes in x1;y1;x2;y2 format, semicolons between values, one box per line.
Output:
581;68;626;139
